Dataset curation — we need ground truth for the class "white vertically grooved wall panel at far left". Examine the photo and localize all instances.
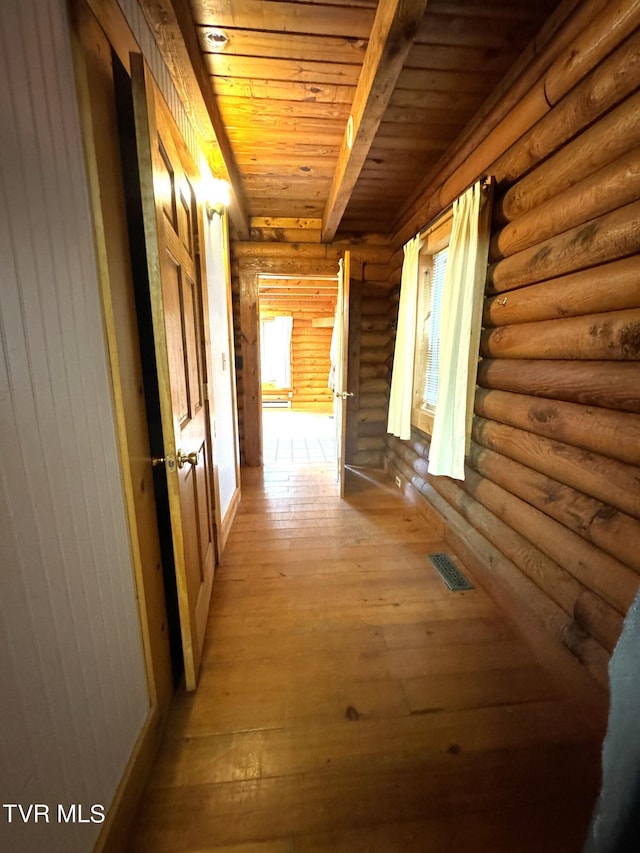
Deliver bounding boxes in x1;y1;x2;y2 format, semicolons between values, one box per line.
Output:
0;0;149;853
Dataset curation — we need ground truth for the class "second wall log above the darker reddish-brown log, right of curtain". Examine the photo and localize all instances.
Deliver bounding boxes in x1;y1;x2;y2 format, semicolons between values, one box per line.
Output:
483;255;640;327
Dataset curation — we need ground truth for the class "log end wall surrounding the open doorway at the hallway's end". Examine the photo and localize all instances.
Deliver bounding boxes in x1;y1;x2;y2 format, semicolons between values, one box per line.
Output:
231;230;395;467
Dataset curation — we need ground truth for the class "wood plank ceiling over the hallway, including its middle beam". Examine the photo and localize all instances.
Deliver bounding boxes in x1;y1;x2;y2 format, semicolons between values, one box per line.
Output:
141;0;558;240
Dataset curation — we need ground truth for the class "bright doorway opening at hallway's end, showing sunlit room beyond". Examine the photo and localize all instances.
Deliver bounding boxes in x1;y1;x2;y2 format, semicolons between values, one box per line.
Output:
258;274;338;467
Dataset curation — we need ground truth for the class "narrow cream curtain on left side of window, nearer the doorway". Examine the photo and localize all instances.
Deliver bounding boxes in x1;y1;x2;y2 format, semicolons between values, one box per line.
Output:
387;234;422;439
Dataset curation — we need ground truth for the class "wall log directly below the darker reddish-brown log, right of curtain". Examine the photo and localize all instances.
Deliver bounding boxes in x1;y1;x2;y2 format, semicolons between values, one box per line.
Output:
475;388;640;465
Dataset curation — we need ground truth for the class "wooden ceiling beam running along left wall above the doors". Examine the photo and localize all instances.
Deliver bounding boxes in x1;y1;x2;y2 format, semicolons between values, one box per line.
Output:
141;0;249;239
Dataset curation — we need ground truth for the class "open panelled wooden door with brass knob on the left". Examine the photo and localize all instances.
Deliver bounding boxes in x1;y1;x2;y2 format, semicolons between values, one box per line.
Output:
131;54;215;690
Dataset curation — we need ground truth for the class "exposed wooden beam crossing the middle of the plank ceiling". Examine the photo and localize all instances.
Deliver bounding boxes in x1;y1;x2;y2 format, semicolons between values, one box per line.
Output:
322;0;427;242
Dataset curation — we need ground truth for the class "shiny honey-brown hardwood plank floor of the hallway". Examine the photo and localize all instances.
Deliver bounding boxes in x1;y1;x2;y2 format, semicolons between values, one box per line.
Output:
130;467;604;853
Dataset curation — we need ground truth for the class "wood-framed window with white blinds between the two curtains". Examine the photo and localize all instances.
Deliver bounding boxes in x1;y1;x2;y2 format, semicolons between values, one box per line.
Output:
411;212;452;434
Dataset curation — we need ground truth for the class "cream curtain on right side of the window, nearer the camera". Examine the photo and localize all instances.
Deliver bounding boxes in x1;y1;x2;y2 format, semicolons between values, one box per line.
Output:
428;181;491;480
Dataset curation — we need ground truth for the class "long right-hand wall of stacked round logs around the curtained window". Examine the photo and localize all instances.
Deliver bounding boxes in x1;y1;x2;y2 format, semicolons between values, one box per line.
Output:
387;0;640;683
